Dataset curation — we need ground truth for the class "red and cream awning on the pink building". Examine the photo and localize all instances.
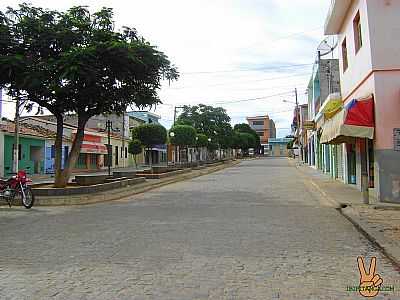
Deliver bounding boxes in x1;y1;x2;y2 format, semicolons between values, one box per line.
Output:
320;96;375;144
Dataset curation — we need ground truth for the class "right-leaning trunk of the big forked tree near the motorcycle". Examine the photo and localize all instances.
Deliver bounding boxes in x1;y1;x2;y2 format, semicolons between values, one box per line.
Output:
57;116;87;187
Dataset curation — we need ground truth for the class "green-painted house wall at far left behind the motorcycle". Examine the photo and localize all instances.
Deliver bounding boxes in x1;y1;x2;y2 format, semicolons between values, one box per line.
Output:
4;135;45;176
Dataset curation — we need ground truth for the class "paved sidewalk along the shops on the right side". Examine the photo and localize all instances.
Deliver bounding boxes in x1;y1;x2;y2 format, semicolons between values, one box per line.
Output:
293;161;400;266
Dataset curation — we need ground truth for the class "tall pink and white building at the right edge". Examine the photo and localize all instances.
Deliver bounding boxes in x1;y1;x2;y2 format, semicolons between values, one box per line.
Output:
325;0;400;202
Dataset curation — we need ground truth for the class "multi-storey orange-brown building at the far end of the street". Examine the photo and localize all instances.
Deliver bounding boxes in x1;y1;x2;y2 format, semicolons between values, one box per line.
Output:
246;115;276;154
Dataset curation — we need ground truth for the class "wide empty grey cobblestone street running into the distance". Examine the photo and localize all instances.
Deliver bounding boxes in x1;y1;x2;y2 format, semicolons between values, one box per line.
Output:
0;159;400;300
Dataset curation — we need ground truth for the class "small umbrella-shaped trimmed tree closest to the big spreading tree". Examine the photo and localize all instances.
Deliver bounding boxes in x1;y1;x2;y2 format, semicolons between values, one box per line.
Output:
132;123;167;166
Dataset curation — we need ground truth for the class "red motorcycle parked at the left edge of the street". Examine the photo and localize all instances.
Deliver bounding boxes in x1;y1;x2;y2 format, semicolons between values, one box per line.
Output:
0;170;35;208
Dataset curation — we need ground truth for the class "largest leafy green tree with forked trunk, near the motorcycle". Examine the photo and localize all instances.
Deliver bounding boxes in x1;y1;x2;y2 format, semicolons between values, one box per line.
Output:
0;4;178;187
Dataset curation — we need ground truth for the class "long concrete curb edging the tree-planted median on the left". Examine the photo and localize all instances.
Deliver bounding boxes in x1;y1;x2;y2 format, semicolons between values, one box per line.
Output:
35;161;240;206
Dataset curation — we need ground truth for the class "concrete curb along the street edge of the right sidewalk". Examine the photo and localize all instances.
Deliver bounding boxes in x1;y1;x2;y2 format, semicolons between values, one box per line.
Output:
296;161;400;268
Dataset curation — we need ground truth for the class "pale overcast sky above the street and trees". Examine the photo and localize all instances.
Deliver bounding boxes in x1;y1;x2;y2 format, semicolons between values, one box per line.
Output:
0;0;330;137
